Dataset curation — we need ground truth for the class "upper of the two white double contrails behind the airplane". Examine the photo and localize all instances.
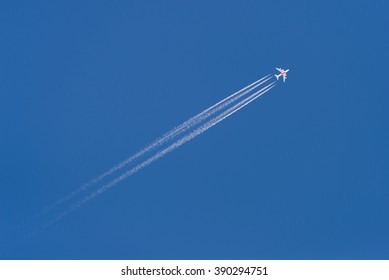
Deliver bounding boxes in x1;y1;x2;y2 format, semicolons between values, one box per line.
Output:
42;74;272;213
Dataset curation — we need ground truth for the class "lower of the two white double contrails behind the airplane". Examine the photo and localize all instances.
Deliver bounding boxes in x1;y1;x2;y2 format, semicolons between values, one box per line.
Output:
45;82;276;227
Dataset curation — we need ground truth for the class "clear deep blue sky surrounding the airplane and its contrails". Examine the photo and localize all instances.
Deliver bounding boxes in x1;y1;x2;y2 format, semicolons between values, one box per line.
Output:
0;0;389;259
